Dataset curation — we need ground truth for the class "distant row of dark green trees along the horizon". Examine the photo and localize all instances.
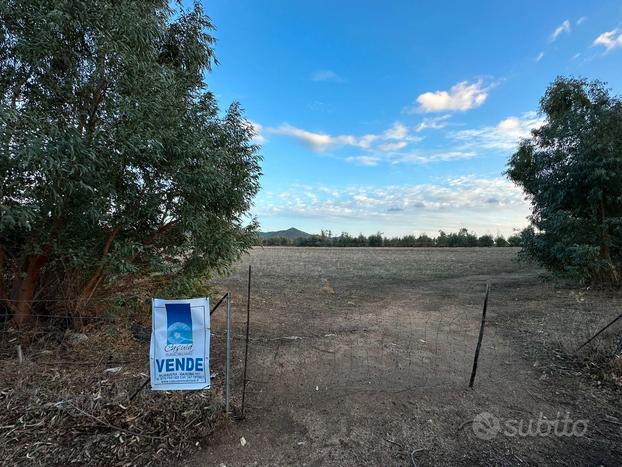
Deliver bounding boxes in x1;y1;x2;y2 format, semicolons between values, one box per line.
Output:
259;228;521;247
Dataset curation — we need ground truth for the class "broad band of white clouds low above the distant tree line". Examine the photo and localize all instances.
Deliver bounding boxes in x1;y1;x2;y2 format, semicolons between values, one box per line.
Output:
257;177;529;234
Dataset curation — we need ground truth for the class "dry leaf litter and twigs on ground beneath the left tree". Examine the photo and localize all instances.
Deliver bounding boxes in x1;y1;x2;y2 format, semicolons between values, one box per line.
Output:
0;319;228;465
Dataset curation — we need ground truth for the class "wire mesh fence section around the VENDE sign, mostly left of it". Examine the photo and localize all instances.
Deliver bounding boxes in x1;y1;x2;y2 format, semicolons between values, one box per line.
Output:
0;294;234;389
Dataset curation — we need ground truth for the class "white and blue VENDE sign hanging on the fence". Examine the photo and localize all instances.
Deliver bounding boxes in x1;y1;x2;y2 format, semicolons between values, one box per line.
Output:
150;298;210;391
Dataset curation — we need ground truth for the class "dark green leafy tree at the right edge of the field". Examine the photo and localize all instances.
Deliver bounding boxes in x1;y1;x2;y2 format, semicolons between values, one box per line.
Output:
507;78;622;284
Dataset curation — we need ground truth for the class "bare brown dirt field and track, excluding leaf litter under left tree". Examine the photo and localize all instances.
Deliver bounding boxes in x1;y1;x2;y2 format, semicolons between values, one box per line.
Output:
187;247;622;466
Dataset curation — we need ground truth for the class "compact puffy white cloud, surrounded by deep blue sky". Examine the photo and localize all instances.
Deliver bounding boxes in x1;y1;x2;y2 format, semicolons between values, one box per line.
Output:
404;80;488;113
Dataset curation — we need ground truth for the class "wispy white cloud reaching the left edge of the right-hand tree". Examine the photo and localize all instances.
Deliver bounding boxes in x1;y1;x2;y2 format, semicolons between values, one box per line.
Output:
450;112;543;151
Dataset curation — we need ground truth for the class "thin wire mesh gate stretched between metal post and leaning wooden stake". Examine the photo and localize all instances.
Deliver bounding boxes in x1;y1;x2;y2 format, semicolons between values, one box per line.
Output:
236;288;515;410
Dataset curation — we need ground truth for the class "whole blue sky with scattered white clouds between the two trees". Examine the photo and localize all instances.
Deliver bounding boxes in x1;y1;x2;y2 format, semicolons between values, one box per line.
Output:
203;0;622;236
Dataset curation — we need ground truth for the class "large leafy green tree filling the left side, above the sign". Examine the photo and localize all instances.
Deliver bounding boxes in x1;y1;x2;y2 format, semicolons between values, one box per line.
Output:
0;0;260;320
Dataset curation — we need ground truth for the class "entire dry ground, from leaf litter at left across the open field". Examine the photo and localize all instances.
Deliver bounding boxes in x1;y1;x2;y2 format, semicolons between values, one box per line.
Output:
0;248;622;465
